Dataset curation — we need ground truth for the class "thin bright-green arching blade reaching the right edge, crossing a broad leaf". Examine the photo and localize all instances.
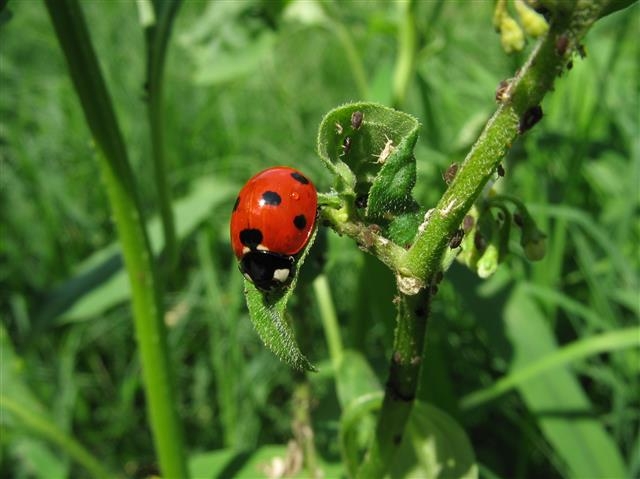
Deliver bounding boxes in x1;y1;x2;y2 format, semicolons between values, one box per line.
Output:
460;327;640;410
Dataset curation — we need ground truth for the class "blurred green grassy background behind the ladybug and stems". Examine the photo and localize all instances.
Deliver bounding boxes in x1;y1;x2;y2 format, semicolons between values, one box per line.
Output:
0;0;640;477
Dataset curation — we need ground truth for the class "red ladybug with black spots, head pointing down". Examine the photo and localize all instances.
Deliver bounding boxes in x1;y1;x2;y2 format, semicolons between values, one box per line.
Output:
230;166;318;291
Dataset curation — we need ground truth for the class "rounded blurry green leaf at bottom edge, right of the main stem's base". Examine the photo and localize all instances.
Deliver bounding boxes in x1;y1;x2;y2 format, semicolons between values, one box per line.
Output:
387;401;478;479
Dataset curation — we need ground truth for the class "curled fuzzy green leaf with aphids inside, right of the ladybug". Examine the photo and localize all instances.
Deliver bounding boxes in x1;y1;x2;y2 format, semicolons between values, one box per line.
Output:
318;103;421;245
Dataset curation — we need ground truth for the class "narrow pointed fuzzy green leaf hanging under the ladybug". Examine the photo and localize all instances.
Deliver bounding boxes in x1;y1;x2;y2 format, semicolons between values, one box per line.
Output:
244;229;317;371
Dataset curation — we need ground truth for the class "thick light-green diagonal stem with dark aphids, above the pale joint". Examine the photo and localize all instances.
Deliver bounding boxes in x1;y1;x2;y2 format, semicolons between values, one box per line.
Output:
402;0;606;279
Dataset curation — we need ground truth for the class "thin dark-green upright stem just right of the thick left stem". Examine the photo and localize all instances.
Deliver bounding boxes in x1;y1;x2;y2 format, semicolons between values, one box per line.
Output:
145;0;180;278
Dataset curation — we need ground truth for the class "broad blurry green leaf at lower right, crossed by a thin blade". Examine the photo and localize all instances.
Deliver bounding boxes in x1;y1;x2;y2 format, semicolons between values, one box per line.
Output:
504;287;627;478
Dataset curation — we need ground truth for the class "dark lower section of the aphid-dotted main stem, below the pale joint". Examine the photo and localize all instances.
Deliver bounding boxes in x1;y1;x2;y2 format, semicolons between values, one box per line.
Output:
356;288;431;479
